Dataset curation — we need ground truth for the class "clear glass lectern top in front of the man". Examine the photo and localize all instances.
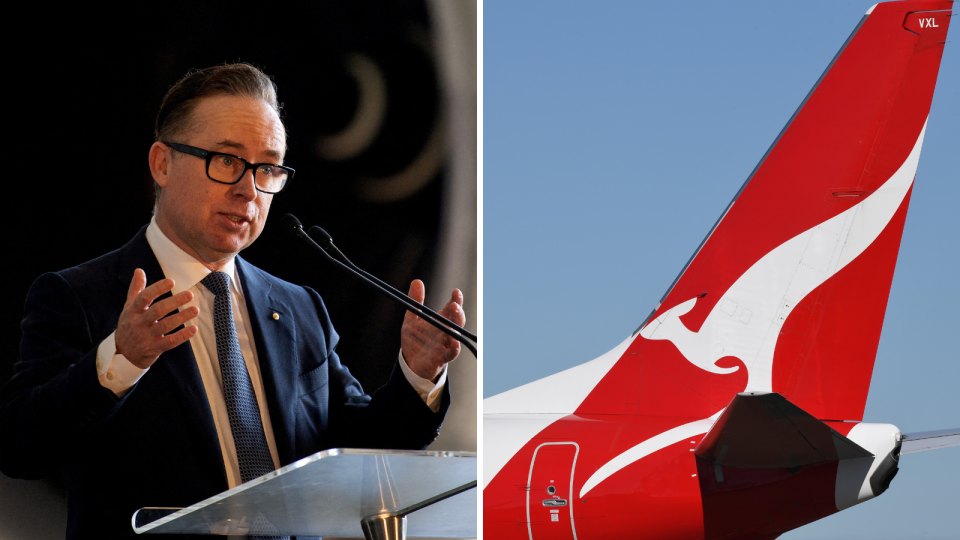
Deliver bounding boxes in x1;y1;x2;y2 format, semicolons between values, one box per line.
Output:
132;448;477;540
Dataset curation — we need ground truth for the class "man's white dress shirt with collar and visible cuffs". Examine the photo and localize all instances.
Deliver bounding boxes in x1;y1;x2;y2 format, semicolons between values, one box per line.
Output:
97;219;447;488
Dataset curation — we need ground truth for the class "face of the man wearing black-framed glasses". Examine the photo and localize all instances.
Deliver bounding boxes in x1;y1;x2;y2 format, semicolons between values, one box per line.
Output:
150;96;286;269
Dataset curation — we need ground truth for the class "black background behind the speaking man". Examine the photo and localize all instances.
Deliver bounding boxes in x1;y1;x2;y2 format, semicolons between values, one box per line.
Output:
0;1;446;392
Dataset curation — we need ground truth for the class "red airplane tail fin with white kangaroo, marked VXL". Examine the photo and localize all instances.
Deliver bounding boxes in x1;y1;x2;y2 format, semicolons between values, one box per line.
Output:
577;0;952;420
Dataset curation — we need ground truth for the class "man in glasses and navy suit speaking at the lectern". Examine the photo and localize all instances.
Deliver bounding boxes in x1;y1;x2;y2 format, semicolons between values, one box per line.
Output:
0;64;464;538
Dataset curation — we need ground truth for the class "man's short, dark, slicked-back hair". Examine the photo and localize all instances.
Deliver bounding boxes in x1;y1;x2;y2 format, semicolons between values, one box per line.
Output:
153;63;282;207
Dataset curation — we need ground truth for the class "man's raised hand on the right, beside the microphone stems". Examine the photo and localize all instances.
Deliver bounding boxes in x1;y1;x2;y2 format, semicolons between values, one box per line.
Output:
400;279;467;381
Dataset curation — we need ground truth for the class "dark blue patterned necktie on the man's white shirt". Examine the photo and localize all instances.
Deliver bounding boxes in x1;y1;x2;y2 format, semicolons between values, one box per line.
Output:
200;272;286;534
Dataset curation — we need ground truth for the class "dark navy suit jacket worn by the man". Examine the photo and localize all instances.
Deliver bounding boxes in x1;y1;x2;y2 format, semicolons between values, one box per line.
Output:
0;228;449;539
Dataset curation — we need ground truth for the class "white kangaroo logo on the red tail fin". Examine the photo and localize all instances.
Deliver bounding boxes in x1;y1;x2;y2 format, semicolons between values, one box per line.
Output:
640;122;927;392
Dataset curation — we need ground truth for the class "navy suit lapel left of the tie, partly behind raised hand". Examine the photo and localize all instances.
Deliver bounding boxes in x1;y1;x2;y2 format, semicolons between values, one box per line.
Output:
117;227;227;485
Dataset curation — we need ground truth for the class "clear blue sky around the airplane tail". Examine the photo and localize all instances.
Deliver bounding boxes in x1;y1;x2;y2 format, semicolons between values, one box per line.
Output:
482;0;960;540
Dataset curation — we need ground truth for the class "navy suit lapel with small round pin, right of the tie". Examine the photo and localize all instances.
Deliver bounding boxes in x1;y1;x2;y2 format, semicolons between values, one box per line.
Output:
236;256;297;466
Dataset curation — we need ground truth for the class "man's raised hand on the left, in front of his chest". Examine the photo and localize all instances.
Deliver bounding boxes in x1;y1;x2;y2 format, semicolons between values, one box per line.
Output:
115;268;200;369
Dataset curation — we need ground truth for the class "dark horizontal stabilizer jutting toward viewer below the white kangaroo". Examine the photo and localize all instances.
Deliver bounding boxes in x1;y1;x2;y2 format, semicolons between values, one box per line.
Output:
696;392;873;469
